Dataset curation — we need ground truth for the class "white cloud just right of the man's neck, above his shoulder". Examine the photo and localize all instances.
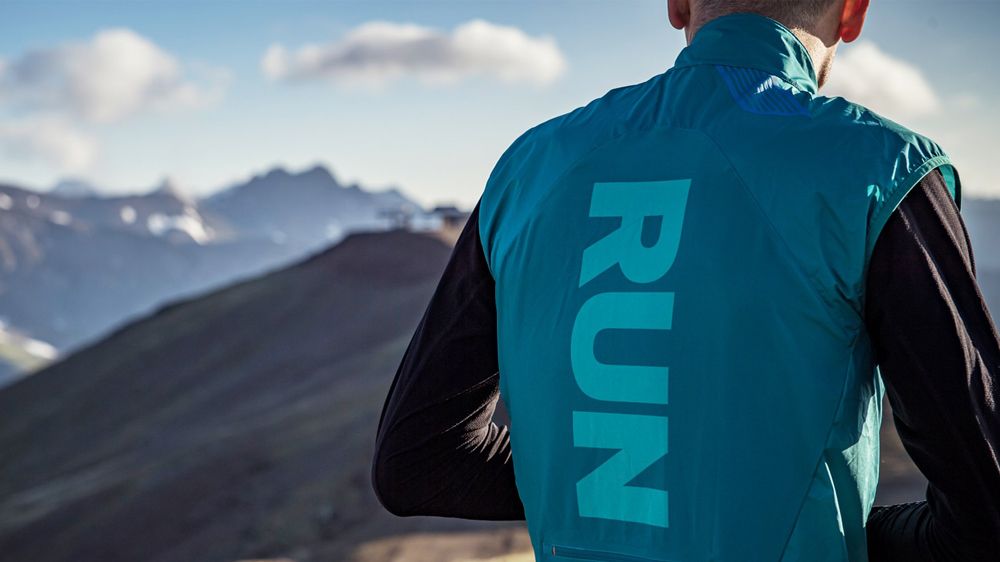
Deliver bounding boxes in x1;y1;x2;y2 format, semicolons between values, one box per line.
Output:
822;41;941;118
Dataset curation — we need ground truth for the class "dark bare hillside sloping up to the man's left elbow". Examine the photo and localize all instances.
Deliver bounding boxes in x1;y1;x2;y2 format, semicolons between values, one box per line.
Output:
0;231;528;562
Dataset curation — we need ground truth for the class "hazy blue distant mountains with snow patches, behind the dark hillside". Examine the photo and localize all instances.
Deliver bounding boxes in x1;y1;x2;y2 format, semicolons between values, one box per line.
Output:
0;162;422;366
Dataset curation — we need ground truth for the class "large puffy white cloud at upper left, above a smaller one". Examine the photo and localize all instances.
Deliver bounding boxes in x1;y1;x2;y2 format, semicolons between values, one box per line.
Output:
0;28;227;123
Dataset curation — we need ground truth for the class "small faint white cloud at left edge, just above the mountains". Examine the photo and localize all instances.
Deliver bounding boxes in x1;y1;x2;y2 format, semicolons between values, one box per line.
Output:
0;116;97;173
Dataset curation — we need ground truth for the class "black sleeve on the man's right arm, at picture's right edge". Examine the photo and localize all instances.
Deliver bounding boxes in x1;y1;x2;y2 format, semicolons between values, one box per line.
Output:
865;170;1000;562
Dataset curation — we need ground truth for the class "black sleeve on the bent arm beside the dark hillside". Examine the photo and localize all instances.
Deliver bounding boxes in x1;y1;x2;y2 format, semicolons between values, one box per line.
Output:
372;199;524;520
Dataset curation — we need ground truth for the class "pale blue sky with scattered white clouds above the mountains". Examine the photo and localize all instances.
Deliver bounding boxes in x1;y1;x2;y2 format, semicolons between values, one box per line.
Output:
0;0;1000;208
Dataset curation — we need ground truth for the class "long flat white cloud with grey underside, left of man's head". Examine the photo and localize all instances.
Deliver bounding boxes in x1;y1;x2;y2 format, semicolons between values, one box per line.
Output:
261;20;566;87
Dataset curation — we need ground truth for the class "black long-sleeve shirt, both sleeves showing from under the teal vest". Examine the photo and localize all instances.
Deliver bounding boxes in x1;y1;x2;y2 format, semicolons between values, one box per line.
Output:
372;170;1000;562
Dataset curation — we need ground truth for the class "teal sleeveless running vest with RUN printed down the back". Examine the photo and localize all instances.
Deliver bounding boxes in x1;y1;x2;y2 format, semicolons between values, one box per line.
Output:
479;14;960;562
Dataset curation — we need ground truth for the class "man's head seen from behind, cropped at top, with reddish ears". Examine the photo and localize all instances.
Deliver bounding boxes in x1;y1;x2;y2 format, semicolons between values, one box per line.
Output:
667;0;869;87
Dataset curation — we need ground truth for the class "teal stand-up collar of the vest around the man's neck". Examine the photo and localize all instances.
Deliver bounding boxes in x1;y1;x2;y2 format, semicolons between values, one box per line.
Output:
674;12;818;94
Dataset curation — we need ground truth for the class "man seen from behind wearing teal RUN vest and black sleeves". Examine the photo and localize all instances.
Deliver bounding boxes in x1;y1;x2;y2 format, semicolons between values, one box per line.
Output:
372;0;1000;561
